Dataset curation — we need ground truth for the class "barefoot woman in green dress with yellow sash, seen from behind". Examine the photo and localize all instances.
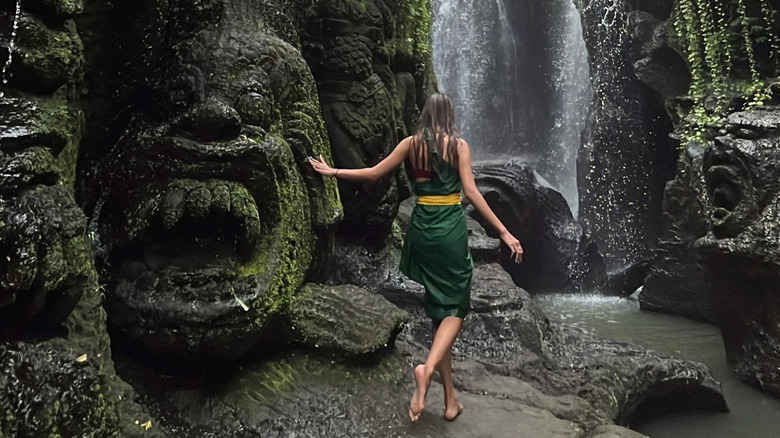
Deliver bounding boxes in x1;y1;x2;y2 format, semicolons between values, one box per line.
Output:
310;93;523;421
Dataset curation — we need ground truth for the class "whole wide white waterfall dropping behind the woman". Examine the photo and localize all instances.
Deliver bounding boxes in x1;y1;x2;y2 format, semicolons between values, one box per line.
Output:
431;0;592;214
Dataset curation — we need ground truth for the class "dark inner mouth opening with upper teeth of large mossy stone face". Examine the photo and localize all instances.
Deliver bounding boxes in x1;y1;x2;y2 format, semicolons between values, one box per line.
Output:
105;180;266;303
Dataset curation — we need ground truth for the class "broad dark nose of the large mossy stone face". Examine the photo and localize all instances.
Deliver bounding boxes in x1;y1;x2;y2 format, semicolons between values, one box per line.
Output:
178;98;241;141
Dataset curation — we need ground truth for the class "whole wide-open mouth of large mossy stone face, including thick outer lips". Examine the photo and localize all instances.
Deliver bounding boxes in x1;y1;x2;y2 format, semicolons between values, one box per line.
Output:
99;135;289;356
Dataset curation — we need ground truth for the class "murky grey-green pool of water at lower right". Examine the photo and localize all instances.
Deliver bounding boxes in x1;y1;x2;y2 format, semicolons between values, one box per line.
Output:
537;295;780;438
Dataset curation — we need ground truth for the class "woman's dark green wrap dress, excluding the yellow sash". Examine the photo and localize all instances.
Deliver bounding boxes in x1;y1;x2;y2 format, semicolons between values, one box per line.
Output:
400;149;473;321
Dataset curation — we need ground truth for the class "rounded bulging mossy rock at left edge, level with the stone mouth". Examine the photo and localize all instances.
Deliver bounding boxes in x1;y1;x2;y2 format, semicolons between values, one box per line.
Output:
0;185;94;339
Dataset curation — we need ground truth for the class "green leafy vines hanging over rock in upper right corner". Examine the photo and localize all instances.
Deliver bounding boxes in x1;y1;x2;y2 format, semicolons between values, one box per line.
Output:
670;0;780;144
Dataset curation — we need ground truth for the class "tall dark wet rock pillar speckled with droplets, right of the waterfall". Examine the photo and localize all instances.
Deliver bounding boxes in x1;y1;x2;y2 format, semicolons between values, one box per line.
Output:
574;0;678;271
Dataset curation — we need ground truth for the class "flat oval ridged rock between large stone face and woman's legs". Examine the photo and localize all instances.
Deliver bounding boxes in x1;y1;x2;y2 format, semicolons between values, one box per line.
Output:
290;284;409;355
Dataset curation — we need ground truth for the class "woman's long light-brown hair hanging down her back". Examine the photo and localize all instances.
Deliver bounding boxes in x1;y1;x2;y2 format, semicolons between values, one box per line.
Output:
415;93;458;166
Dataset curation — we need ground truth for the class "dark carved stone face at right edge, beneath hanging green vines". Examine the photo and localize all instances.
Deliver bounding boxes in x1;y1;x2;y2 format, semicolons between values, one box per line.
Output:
696;112;780;395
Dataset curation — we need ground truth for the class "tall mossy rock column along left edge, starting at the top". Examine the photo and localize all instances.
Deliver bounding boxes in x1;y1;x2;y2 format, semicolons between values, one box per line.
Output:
0;0;87;340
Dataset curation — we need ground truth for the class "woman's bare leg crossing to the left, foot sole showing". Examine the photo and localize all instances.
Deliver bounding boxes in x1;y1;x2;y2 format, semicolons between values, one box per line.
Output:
409;316;463;421
